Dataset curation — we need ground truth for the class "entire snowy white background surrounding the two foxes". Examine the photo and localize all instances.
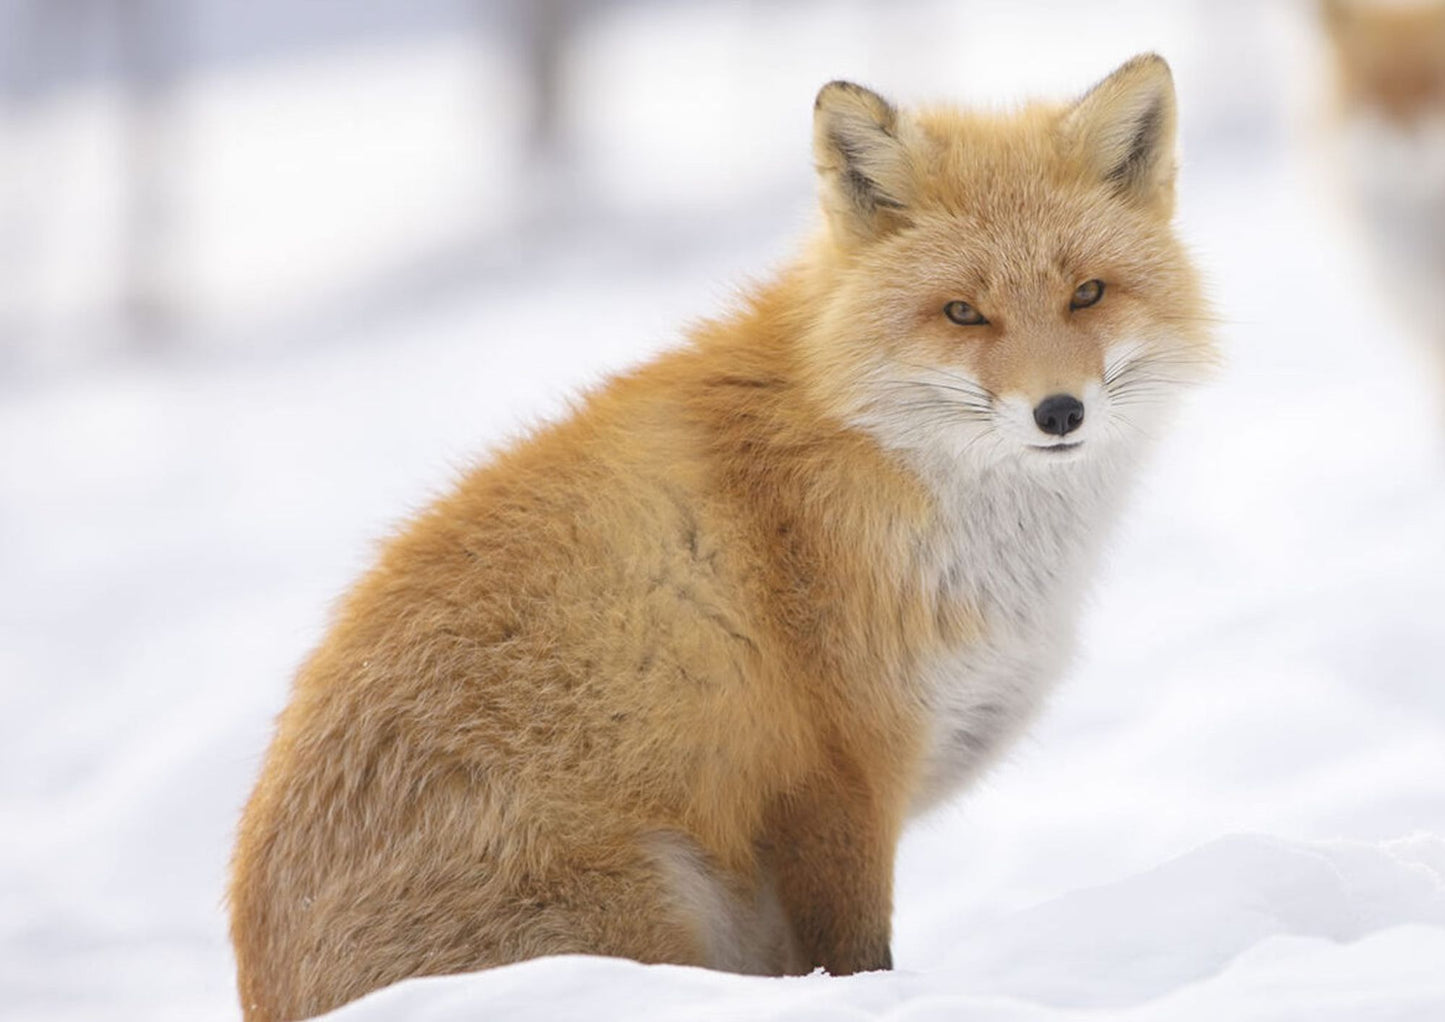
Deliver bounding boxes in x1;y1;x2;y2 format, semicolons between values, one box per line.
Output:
0;0;1445;1022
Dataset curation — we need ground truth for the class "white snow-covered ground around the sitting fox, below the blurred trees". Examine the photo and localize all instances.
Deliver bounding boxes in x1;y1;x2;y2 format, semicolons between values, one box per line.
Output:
0;1;1445;1022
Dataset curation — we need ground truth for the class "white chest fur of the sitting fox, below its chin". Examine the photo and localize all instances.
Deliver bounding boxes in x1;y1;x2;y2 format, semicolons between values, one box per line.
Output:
913;458;1129;811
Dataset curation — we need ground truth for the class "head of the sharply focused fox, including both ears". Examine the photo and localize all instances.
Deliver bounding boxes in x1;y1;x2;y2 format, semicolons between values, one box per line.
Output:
808;55;1211;473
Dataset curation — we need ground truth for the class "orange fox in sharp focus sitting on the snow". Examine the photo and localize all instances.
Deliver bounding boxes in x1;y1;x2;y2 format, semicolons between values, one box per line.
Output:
228;53;1215;1022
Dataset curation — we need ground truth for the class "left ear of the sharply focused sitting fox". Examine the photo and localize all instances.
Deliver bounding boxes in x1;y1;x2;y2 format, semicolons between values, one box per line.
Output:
814;81;913;243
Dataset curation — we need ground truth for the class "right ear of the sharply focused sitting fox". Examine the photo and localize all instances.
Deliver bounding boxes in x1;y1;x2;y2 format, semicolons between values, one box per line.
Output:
1062;53;1178;214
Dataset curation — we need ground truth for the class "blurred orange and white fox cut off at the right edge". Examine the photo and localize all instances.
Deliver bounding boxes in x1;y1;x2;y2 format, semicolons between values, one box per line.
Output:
1321;0;1445;387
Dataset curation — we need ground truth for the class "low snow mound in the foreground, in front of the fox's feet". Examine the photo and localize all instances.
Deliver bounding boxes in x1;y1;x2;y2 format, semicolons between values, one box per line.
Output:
327;836;1445;1022
